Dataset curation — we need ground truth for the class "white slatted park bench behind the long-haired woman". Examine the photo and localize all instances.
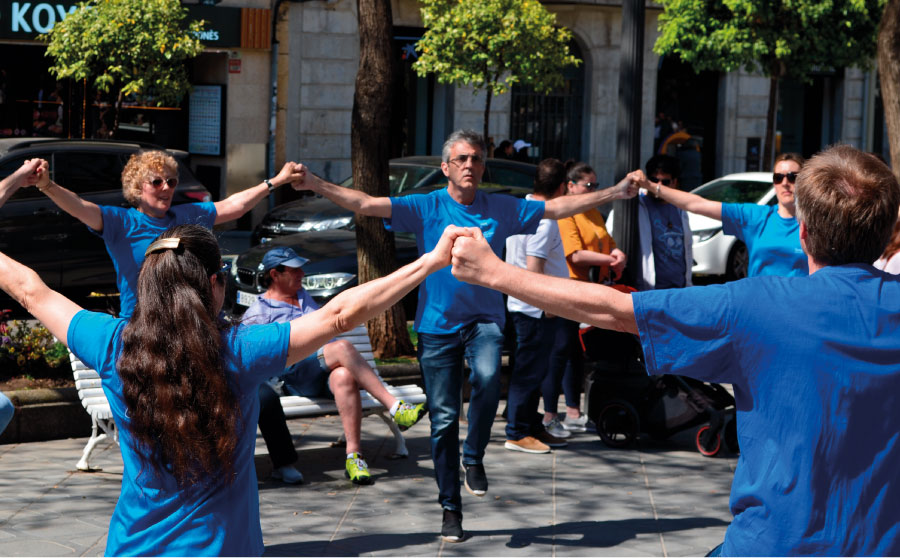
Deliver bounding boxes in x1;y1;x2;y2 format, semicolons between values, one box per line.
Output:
69;326;425;471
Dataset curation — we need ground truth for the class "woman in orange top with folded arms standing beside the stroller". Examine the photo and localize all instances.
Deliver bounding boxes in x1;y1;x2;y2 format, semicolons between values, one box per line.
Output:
541;163;625;438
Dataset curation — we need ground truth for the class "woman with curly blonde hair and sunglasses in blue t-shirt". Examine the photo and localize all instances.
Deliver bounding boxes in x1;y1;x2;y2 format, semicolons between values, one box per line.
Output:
30;150;302;318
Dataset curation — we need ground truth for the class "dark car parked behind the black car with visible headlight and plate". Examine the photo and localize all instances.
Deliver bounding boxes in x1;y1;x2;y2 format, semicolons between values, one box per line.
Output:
251;156;537;245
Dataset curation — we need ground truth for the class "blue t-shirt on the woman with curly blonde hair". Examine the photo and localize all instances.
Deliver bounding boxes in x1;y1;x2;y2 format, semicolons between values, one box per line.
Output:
99;202;216;318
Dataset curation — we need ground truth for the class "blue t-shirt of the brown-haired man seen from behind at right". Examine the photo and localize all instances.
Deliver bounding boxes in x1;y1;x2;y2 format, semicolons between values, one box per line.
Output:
632;264;900;556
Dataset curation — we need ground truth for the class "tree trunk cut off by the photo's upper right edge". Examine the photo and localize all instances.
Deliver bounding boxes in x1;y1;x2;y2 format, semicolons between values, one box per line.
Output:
878;0;900;177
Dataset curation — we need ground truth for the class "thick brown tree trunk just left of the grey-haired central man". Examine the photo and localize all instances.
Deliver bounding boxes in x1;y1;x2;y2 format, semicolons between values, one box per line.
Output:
350;0;413;358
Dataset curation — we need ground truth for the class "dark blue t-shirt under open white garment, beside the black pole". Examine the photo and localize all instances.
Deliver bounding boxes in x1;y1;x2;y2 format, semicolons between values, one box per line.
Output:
644;196;686;289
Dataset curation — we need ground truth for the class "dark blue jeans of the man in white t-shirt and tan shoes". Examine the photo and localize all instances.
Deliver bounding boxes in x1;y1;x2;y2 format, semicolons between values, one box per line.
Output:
506;312;563;440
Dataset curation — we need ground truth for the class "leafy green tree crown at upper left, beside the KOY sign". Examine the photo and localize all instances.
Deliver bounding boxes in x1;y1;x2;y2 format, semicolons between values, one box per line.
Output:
40;0;203;136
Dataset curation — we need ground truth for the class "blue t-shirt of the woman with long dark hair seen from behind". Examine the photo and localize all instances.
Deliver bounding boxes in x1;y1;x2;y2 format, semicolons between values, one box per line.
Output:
68;310;290;556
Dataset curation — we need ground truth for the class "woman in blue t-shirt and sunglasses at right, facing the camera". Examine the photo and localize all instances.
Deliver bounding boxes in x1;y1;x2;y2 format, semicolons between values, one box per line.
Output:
642;153;809;277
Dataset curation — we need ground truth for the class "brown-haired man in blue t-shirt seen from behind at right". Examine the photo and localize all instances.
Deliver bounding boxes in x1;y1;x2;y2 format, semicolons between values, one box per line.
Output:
452;145;900;556
